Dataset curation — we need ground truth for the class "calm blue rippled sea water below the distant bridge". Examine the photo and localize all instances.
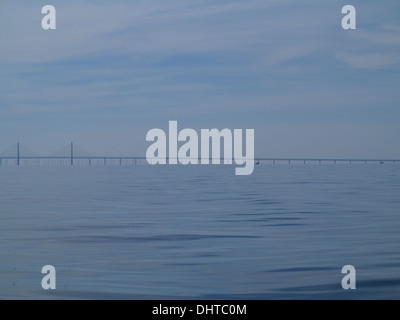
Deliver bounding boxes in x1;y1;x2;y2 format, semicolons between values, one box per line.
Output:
0;165;400;299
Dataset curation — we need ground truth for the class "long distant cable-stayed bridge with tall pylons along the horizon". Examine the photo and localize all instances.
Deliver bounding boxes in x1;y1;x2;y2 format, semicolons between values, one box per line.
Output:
0;143;400;166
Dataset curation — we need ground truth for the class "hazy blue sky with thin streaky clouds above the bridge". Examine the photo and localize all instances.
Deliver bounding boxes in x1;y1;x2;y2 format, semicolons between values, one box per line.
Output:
0;0;400;159
